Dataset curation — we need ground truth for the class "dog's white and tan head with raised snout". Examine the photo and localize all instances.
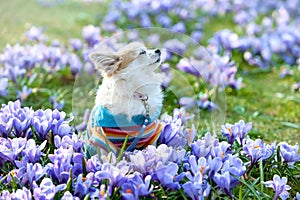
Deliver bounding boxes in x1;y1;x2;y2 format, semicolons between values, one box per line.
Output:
90;42;161;76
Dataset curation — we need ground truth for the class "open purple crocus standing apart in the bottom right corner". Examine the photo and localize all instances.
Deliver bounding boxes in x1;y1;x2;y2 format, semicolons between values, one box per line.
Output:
264;174;291;200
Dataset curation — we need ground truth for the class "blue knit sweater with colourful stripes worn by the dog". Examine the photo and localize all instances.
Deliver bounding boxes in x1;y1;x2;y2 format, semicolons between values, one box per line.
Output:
85;105;162;157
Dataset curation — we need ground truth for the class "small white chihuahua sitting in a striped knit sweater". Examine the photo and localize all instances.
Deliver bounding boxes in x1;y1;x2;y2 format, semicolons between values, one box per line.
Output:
86;42;163;156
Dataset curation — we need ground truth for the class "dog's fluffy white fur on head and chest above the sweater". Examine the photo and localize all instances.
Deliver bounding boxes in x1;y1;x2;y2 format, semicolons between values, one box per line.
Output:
90;42;163;119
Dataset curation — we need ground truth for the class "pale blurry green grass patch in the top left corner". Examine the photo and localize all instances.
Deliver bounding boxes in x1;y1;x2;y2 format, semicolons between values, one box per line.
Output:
0;0;107;49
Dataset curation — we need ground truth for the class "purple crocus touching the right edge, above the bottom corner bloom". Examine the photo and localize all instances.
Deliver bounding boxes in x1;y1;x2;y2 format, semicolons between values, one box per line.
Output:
278;142;300;165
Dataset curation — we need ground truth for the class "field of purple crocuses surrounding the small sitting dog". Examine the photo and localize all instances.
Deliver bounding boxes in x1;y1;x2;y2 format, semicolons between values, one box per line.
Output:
0;0;300;200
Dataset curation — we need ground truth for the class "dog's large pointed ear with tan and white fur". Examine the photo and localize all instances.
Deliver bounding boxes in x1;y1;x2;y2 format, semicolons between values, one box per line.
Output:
89;52;122;76
